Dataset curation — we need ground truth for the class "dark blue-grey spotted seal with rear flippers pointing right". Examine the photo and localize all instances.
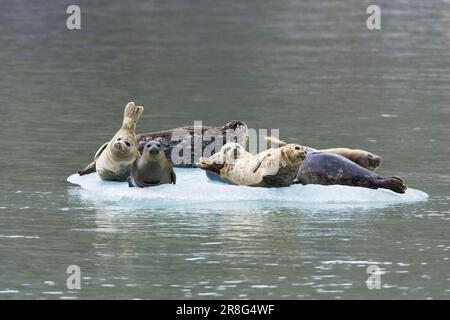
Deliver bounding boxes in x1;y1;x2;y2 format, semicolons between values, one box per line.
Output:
294;152;406;193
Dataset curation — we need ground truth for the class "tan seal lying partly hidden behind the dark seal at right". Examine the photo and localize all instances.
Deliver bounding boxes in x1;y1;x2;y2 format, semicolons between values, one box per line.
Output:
266;137;381;171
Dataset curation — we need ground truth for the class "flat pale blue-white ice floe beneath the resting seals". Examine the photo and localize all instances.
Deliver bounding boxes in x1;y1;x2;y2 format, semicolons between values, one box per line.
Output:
67;168;428;207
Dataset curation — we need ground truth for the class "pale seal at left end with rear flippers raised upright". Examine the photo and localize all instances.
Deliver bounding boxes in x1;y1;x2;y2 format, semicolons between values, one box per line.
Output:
78;102;144;181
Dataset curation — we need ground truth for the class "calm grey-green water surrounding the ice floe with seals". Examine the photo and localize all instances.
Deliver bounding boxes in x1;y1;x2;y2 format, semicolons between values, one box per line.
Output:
0;0;450;299
